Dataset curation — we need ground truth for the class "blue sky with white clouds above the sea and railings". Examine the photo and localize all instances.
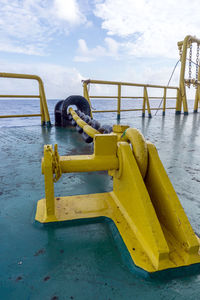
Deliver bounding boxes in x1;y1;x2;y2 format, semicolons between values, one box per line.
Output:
0;0;200;99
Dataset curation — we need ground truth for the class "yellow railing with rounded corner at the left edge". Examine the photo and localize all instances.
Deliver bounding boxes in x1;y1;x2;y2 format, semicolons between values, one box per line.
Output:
0;73;51;126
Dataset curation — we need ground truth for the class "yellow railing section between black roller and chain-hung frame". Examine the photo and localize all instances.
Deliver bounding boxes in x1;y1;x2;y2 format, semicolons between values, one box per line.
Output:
83;79;180;119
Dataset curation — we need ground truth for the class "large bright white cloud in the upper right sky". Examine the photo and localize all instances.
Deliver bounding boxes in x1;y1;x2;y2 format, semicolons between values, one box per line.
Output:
94;0;200;58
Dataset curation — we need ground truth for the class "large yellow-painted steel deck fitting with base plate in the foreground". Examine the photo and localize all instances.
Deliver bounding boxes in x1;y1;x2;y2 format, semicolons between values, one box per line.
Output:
35;108;200;273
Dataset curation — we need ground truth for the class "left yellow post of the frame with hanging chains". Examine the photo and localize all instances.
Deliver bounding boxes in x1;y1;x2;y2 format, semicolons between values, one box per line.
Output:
176;35;192;115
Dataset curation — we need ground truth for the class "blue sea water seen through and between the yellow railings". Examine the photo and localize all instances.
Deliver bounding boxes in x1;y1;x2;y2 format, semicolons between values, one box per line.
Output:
0;99;194;127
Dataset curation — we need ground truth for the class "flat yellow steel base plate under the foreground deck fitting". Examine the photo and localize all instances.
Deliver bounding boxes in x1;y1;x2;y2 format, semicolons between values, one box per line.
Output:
36;192;200;273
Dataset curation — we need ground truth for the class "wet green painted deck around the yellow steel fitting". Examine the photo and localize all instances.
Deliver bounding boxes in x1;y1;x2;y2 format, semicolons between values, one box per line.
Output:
0;114;200;300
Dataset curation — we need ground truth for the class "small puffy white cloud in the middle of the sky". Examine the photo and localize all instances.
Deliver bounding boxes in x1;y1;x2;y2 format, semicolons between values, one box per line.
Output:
74;37;118;62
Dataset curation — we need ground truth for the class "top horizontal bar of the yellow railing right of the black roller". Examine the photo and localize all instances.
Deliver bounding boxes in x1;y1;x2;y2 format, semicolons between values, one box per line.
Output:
83;79;179;90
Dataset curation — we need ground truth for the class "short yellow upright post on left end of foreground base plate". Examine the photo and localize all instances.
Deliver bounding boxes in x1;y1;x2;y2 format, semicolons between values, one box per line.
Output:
44;145;56;222
